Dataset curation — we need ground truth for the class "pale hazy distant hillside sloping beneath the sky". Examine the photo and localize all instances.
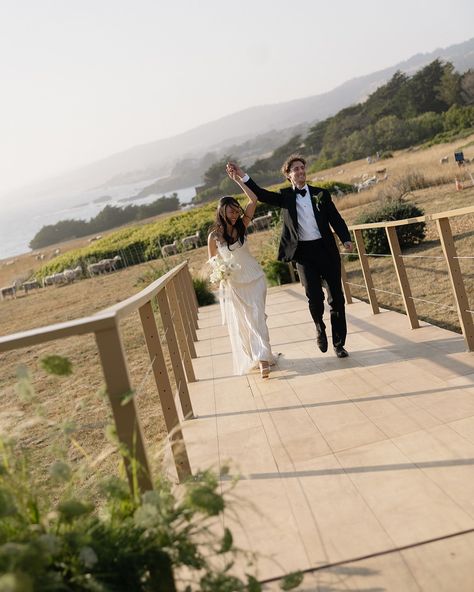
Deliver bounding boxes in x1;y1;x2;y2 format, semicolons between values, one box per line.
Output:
10;38;474;208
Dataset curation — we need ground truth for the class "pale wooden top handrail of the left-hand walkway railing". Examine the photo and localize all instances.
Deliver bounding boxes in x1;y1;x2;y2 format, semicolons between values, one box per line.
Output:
0;261;187;352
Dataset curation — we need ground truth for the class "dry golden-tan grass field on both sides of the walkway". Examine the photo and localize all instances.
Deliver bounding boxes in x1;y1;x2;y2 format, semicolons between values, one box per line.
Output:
0;136;474;488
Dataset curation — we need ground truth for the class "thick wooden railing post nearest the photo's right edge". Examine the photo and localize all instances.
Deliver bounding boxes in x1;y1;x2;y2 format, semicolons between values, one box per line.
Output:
436;218;474;351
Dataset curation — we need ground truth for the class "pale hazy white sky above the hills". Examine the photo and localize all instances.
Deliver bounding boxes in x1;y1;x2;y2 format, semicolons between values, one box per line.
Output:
0;0;474;195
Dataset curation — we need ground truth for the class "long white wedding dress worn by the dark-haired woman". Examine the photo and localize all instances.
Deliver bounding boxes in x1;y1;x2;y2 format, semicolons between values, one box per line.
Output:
217;239;274;374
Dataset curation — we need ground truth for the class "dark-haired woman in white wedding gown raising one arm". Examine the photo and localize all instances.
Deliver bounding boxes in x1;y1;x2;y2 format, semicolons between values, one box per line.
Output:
207;174;275;378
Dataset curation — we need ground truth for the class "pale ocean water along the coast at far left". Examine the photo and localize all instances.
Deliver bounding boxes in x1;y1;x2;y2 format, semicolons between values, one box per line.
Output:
0;179;196;259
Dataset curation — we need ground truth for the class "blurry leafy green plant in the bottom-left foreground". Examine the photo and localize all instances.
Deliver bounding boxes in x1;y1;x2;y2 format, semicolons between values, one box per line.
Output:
0;356;302;592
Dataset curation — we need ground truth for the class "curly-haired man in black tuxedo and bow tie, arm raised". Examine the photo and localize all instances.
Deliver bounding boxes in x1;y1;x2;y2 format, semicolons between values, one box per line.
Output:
227;154;352;358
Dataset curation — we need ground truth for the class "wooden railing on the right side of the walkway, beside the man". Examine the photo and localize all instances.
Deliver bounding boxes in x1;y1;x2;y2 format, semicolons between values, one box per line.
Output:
342;206;474;351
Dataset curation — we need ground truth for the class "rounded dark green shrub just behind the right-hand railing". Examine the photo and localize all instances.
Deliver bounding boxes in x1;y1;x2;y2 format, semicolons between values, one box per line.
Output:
355;199;426;254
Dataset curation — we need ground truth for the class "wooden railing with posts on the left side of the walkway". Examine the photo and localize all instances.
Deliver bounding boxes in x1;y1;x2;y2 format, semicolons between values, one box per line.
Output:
0;262;198;491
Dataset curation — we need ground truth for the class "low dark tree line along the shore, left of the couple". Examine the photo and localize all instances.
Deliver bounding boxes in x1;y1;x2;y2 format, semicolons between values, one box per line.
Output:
29;193;180;249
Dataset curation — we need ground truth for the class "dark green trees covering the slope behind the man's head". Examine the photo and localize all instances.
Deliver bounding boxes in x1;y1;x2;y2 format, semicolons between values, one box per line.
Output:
195;59;474;202
